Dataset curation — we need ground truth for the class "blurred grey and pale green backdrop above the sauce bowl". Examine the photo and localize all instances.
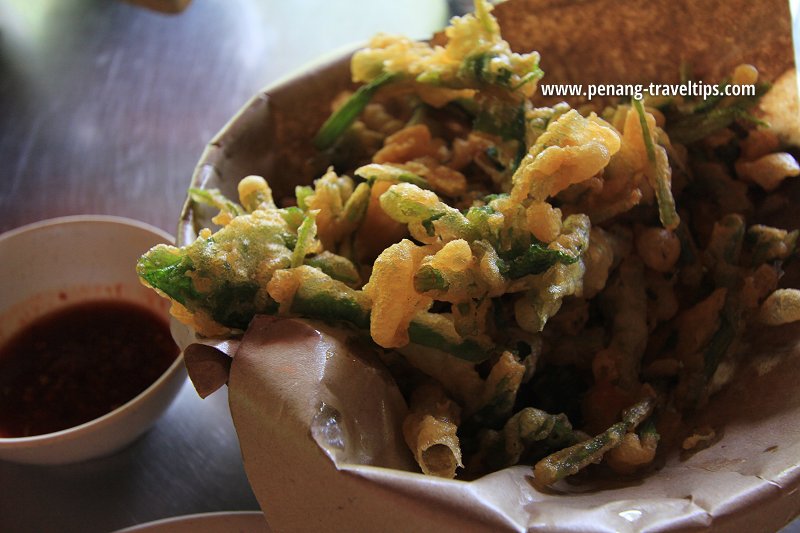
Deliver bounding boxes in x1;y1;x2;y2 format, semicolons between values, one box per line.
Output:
0;0;454;233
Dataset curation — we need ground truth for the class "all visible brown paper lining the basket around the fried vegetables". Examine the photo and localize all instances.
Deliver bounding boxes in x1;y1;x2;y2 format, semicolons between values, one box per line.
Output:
176;0;800;531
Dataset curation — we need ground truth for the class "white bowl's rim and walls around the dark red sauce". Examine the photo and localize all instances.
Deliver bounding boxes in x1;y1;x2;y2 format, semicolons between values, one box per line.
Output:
0;215;186;464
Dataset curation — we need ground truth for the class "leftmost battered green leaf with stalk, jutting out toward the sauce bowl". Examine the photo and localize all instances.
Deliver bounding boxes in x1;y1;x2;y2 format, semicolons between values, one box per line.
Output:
137;189;491;361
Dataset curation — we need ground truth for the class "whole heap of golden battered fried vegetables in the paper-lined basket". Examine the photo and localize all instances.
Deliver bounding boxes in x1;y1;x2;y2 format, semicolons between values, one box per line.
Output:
137;0;800;485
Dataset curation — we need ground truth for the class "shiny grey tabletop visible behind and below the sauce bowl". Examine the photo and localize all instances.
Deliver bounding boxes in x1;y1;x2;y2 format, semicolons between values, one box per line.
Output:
0;0;800;532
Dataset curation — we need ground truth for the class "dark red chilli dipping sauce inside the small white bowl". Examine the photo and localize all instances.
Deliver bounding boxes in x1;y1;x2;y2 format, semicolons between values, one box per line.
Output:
0;300;179;437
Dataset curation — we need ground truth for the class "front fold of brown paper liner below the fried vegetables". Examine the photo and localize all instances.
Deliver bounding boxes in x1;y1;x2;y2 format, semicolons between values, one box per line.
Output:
195;317;800;531
